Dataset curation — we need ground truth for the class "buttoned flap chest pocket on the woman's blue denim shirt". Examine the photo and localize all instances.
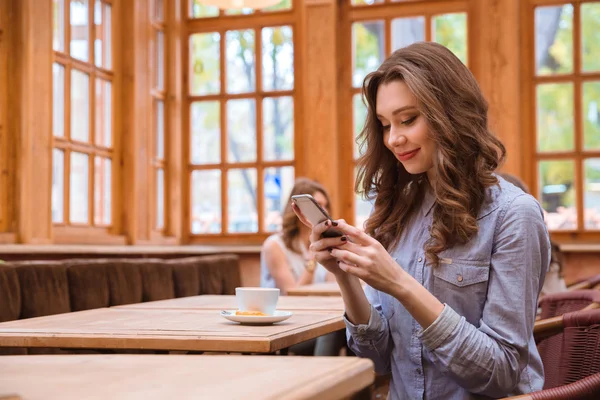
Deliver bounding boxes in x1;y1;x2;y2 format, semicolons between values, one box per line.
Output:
433;258;490;326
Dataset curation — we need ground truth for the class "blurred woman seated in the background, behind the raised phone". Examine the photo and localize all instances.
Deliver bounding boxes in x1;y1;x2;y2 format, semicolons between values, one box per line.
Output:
260;178;335;295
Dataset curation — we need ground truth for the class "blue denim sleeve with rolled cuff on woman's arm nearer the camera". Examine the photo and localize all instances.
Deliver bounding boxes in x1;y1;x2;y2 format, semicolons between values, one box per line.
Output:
419;196;550;397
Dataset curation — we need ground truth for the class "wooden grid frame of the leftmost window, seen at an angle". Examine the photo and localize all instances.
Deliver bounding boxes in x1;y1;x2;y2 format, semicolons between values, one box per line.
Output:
52;0;125;244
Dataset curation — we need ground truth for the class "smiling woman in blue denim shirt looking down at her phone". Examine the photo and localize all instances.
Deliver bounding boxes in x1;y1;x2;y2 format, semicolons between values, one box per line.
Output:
295;43;550;399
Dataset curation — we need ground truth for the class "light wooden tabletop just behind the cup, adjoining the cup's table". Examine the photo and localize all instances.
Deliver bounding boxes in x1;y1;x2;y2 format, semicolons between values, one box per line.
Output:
117;295;344;314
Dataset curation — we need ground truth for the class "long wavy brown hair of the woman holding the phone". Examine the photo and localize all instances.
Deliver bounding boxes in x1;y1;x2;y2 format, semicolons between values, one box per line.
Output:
355;42;506;266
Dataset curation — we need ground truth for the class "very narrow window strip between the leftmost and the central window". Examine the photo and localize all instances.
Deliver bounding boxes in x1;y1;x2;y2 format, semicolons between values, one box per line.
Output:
150;0;168;232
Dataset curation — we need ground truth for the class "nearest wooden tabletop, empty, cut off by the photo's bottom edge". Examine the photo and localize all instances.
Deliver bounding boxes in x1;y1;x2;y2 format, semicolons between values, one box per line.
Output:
0;355;374;400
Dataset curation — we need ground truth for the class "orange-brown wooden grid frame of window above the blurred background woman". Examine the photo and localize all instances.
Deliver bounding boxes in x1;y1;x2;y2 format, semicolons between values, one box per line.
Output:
182;0;302;245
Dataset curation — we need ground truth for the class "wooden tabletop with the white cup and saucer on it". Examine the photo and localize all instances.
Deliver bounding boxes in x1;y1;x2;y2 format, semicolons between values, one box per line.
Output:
0;307;345;353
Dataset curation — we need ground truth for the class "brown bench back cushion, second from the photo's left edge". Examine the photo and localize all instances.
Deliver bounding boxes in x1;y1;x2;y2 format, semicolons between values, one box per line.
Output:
12;261;71;318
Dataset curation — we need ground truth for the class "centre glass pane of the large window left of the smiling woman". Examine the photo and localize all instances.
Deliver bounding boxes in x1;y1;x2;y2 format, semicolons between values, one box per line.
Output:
227;99;256;162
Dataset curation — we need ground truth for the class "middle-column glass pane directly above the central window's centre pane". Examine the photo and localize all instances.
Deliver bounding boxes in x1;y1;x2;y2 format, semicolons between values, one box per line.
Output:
225;29;256;93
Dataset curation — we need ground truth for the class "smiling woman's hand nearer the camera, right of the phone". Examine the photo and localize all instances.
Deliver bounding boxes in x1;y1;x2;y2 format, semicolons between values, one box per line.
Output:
330;220;406;296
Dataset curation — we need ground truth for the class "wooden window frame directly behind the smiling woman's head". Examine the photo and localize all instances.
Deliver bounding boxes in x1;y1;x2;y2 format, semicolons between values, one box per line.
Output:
338;0;474;225
